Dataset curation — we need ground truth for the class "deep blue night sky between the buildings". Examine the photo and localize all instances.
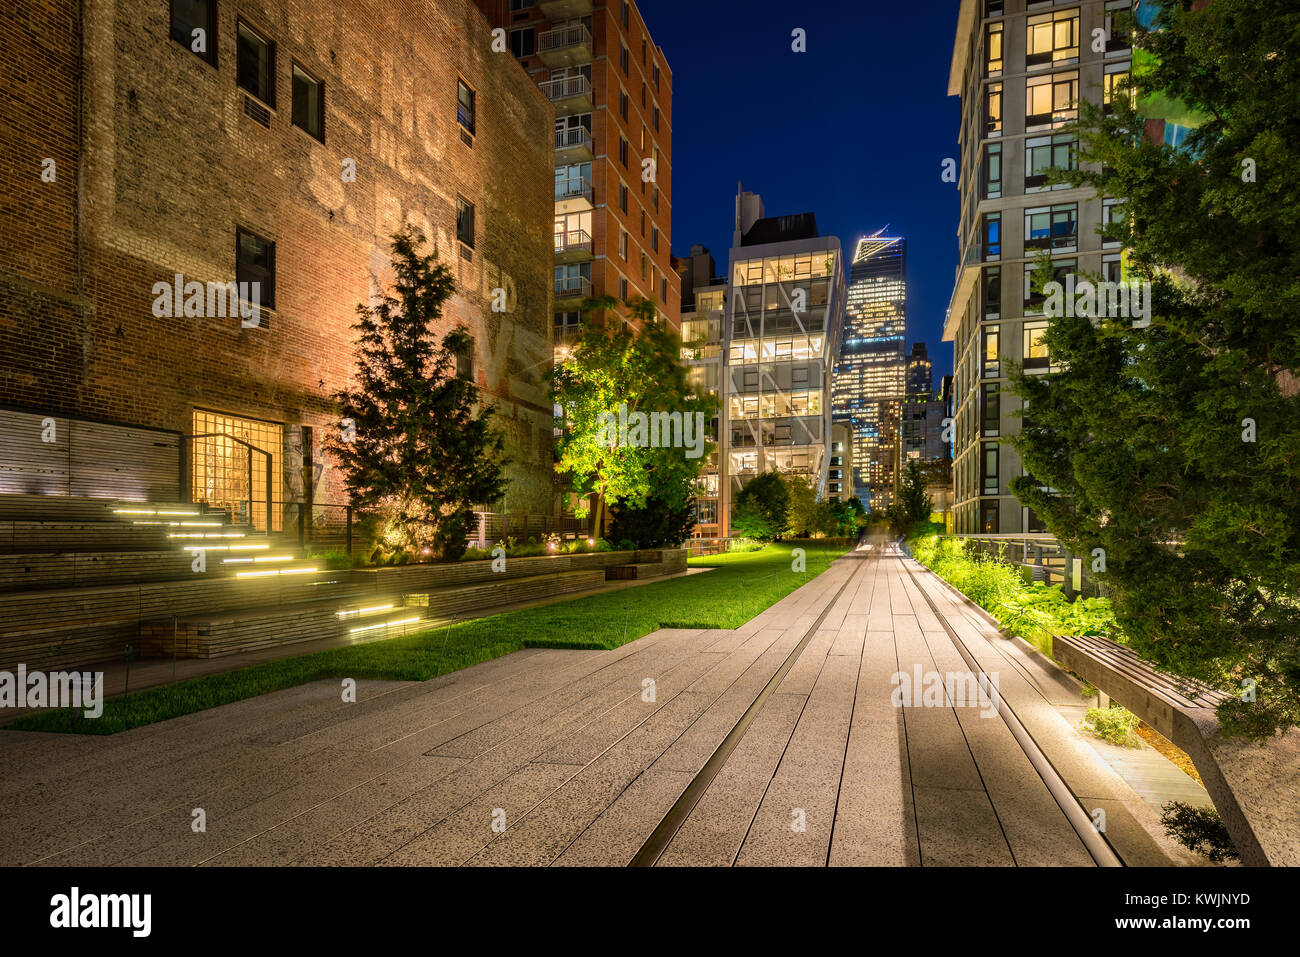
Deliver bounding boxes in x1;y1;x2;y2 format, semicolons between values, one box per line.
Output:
650;0;961;387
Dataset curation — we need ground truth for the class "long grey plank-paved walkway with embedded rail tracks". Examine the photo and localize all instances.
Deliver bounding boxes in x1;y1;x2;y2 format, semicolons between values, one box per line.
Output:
0;551;1187;866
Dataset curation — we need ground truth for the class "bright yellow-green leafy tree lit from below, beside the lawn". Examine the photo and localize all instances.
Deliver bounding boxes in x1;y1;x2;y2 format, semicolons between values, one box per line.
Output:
551;296;718;529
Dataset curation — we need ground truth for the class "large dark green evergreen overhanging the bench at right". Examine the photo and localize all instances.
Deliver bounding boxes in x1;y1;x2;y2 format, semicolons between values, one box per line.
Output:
1011;0;1300;739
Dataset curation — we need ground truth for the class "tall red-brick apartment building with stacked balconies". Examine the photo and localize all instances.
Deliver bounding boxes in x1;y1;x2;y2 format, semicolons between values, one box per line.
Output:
476;0;681;350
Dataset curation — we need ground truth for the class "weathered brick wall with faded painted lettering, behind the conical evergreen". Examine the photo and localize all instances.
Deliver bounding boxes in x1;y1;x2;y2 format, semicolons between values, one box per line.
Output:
0;0;554;512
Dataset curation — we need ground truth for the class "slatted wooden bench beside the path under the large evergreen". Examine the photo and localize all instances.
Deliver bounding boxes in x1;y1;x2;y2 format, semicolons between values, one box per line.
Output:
1052;635;1300;866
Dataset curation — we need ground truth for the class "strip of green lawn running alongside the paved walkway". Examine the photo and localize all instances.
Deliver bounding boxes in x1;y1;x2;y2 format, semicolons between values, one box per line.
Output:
9;542;845;735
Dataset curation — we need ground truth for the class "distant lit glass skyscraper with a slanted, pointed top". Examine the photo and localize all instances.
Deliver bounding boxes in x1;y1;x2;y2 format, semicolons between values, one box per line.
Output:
832;231;907;510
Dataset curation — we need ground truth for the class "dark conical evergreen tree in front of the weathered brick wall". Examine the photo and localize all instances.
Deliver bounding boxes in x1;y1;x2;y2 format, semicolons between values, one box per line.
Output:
326;229;506;560
